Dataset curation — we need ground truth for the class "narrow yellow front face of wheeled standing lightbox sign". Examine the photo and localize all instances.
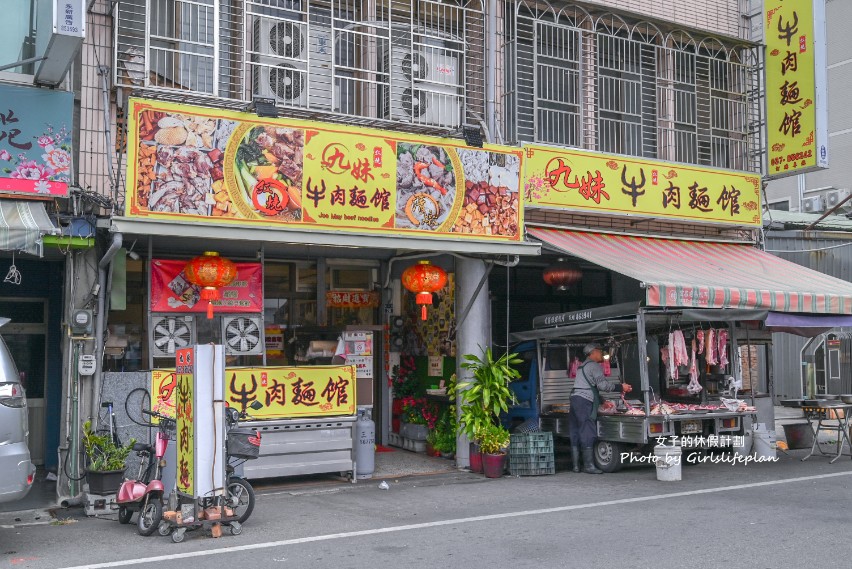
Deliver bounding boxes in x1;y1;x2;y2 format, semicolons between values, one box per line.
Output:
175;348;195;497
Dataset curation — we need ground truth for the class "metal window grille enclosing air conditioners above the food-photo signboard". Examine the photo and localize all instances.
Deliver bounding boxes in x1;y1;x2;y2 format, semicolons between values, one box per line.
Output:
114;0;485;131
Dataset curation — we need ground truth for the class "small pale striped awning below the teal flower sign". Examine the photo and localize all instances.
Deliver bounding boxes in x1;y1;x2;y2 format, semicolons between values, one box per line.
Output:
0;199;59;257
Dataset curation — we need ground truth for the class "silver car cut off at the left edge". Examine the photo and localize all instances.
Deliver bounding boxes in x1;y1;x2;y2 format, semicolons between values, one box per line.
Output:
0;318;35;502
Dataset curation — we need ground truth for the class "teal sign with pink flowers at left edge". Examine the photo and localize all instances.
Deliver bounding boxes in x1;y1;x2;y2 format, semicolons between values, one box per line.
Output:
0;85;74;197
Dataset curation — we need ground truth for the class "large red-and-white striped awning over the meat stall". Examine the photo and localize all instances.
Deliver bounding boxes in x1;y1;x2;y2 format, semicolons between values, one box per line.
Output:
527;226;852;314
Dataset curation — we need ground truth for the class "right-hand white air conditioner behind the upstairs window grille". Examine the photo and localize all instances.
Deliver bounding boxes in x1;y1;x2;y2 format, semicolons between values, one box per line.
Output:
384;30;463;127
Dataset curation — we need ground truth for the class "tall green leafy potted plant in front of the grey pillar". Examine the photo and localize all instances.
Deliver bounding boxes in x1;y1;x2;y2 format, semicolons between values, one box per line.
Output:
457;348;523;442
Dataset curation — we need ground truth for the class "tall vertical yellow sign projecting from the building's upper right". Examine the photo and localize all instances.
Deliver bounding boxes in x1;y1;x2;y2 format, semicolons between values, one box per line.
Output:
763;0;828;178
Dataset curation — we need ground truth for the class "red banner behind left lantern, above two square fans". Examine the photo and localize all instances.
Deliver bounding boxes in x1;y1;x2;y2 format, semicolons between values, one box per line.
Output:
151;259;263;313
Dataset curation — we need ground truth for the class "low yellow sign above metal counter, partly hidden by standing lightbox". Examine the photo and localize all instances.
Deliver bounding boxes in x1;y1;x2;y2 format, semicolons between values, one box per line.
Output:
151;366;355;420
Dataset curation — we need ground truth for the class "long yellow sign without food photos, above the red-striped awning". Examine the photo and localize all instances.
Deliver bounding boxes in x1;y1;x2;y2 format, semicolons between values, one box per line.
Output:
524;145;761;225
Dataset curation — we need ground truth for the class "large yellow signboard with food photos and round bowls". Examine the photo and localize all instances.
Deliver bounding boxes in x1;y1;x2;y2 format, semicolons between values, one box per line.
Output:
126;99;523;242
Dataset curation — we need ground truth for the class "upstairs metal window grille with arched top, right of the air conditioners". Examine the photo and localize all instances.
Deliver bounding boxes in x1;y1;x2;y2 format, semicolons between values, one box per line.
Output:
502;2;763;171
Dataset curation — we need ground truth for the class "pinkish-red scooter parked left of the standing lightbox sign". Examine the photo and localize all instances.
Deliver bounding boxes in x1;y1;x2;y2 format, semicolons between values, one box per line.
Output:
116;410;177;535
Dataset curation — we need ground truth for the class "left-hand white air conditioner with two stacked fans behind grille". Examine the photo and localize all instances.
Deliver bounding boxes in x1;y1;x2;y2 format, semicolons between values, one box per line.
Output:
251;17;334;110
